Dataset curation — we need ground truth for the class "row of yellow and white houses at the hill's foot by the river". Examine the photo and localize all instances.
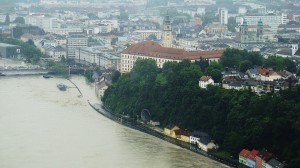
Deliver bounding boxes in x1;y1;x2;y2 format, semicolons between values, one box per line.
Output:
164;124;218;152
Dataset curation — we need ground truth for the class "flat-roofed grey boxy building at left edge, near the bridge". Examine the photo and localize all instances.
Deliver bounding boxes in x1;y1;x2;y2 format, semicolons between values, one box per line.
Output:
0;43;22;58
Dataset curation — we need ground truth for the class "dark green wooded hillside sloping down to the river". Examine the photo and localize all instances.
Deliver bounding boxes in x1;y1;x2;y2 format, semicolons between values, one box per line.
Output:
102;59;300;167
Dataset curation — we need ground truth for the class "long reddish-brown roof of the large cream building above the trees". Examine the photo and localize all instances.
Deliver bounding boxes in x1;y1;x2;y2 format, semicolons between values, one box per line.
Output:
122;41;224;60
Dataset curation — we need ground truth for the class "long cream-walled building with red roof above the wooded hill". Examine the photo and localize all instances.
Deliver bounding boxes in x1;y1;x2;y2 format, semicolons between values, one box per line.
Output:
120;41;224;73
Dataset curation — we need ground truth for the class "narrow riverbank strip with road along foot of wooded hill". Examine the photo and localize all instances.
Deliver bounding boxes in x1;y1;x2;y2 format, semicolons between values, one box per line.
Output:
88;101;240;167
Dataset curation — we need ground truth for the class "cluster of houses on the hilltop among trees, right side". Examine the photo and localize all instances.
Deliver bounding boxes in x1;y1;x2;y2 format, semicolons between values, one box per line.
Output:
199;67;299;93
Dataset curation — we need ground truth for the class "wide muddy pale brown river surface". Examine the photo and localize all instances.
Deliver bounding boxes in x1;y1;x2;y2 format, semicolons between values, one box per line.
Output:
0;60;226;168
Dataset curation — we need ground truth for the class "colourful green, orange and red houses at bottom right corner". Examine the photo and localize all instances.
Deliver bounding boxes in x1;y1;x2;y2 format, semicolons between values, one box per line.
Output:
239;149;286;168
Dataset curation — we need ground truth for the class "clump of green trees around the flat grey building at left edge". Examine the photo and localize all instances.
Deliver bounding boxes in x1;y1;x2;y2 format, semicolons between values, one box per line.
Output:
0;35;42;64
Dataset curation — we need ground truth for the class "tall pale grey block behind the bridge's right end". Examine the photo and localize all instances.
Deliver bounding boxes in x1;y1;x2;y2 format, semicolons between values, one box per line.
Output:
67;34;88;59
